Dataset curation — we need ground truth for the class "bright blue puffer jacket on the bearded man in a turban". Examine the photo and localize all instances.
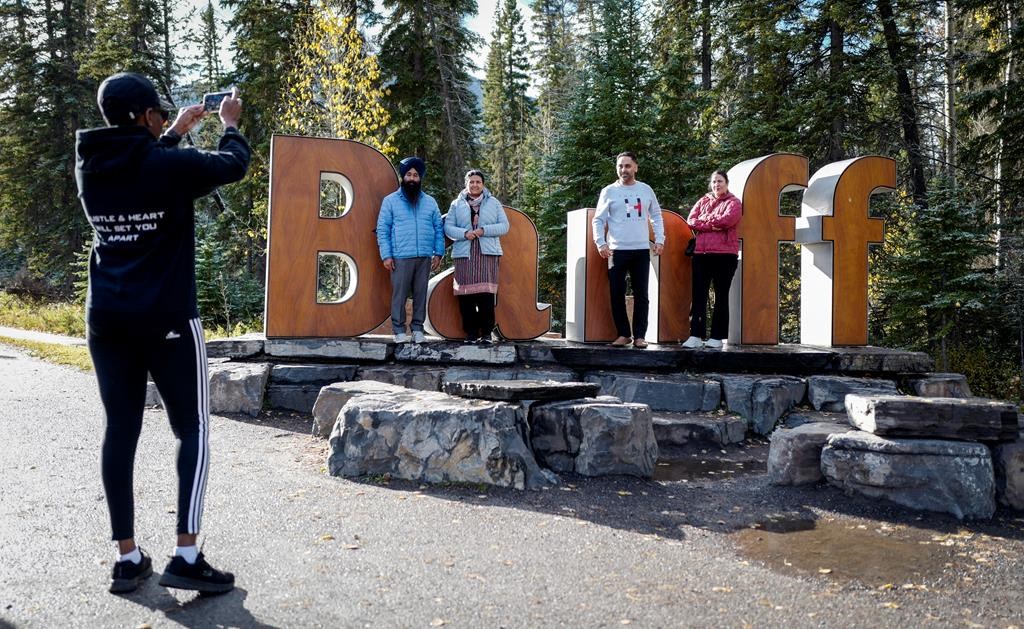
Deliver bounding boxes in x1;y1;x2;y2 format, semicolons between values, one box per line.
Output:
377;187;444;260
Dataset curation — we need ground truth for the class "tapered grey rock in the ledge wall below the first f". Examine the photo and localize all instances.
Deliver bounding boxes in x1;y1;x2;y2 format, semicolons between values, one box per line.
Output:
712;375;807;434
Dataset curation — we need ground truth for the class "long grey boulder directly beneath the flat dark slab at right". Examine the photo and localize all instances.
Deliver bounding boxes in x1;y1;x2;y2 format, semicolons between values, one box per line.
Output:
821;430;995;519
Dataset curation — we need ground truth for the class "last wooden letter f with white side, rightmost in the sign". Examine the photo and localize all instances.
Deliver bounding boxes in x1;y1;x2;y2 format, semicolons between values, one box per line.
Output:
798;156;896;346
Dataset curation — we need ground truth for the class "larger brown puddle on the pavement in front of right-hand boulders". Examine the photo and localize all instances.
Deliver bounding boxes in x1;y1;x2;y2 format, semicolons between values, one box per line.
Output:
733;518;953;588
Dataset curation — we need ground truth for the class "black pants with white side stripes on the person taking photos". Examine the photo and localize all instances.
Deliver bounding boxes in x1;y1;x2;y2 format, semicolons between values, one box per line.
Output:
88;319;210;540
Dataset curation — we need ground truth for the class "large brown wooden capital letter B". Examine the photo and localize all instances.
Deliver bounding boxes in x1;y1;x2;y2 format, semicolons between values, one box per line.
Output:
265;135;398;338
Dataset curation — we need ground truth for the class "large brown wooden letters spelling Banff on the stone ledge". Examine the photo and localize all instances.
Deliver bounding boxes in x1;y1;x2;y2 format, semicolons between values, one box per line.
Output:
264;135;896;346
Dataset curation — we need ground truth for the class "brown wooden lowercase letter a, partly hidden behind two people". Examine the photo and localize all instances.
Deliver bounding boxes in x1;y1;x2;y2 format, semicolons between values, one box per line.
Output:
426;205;551;341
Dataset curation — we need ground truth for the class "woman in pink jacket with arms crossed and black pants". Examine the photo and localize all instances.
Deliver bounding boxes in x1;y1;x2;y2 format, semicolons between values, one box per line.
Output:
683;170;743;349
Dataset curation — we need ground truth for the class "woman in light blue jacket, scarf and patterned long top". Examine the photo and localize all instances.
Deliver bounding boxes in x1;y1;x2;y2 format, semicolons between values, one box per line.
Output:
444;170;509;344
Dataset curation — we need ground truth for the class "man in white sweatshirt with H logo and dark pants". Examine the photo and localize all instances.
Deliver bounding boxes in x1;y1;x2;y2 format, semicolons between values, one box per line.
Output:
593;151;665;348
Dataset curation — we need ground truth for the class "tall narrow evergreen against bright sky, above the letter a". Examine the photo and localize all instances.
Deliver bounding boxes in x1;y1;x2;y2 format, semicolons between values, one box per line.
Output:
483;0;534;205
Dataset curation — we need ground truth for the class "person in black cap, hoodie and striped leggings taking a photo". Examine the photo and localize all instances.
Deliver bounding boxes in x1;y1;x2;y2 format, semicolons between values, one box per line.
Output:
75;73;250;592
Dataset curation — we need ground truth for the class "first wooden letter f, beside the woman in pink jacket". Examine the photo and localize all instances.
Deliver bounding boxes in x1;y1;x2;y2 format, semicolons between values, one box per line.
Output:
729;153;807;345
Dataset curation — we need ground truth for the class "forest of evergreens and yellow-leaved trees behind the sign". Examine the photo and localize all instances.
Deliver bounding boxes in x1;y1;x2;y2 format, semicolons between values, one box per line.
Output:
0;0;1024;400
